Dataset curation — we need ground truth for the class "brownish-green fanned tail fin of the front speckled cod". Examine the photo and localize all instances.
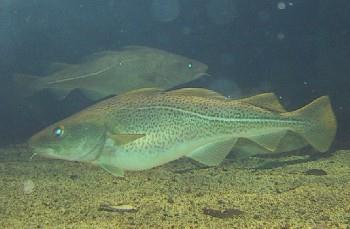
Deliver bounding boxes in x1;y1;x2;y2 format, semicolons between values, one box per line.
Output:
286;96;337;152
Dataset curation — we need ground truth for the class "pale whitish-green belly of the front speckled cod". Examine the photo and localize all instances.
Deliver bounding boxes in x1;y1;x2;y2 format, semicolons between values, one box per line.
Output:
104;132;235;171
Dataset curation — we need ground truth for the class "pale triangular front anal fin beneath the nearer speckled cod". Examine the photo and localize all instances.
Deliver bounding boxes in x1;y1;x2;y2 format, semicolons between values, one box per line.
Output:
188;138;237;166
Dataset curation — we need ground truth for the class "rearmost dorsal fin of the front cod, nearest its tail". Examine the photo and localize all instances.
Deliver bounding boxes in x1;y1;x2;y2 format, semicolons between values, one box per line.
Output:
238;93;286;113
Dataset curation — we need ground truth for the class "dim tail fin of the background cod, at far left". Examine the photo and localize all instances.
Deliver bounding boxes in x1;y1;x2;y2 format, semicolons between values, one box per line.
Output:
13;73;38;98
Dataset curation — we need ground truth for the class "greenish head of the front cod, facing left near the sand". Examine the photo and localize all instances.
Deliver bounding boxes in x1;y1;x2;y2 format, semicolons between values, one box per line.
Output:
28;118;106;161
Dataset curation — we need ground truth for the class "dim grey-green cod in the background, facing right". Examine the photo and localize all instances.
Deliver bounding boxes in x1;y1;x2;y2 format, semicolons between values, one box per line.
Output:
14;46;208;101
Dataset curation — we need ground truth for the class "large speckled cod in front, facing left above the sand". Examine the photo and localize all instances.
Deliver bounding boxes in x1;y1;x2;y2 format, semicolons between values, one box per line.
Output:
29;88;336;176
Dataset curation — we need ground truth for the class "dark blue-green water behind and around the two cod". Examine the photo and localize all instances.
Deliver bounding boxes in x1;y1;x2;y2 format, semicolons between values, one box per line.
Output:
0;0;350;147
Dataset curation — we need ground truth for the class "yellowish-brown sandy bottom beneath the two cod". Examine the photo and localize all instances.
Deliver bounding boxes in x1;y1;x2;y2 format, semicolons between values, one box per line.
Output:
0;146;350;228
